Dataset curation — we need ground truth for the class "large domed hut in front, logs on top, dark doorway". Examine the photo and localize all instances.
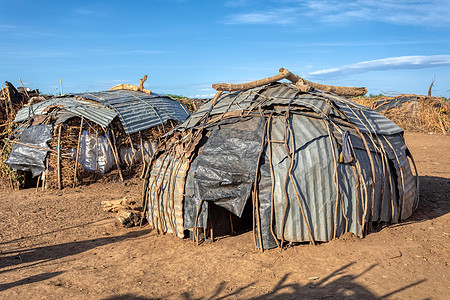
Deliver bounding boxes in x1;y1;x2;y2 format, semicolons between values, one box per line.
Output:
143;70;418;249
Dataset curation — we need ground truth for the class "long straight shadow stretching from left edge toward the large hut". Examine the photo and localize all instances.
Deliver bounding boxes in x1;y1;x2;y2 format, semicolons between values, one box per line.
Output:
0;229;151;274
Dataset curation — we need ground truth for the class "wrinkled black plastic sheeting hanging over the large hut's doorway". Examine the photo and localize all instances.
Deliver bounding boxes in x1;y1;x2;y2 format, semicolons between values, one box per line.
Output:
184;117;264;229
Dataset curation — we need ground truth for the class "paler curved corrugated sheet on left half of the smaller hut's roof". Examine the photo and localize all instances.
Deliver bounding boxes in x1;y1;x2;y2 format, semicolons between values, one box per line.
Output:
14;97;117;127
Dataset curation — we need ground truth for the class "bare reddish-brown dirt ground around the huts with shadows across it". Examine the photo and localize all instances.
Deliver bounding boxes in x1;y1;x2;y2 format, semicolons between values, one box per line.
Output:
0;133;450;299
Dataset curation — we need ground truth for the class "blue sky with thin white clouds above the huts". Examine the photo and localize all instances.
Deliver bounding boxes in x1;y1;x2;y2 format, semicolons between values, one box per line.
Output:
0;0;450;97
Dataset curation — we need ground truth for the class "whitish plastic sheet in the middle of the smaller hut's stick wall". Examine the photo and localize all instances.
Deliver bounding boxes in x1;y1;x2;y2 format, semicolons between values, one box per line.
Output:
78;130;115;174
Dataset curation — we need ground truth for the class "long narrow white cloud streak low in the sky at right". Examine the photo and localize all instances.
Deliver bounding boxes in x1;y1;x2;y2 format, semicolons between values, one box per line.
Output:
307;55;450;78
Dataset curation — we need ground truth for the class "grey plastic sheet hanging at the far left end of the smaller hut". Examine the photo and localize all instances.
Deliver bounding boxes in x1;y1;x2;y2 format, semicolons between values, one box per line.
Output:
5;125;52;177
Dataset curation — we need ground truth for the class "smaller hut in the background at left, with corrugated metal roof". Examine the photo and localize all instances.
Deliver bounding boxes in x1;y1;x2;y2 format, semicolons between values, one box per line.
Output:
5;90;189;188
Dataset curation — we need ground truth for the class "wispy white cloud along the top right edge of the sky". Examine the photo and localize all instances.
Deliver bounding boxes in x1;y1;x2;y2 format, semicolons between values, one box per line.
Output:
226;0;450;27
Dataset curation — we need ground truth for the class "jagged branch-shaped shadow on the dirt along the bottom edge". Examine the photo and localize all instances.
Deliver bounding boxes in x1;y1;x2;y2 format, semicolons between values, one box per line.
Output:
105;262;426;300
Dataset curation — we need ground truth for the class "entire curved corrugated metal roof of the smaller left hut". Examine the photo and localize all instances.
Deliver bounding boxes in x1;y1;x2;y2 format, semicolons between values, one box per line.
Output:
14;90;189;134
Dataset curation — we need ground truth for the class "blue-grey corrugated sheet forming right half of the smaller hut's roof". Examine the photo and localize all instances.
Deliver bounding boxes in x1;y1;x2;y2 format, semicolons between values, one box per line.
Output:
76;90;189;134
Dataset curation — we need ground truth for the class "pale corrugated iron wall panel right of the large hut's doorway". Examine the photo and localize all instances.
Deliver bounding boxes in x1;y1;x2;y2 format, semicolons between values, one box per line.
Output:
267;115;352;242
